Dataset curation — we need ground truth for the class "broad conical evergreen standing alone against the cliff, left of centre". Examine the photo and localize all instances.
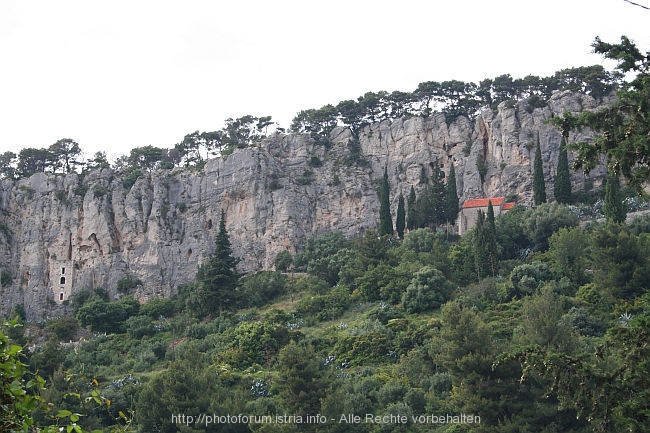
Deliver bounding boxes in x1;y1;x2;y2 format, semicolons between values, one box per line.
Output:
187;210;240;317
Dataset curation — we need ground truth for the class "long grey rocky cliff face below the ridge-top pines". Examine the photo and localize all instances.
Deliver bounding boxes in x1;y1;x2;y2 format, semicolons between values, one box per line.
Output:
0;92;603;320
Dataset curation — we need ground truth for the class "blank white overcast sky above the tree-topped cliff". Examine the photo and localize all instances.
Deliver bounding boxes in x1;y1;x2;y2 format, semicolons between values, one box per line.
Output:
0;0;650;156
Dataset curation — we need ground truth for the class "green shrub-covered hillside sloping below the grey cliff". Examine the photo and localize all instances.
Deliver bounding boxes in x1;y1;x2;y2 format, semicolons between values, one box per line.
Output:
3;204;650;432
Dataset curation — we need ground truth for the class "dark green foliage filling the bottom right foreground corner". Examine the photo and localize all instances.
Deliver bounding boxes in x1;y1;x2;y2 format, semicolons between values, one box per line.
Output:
512;297;650;432
